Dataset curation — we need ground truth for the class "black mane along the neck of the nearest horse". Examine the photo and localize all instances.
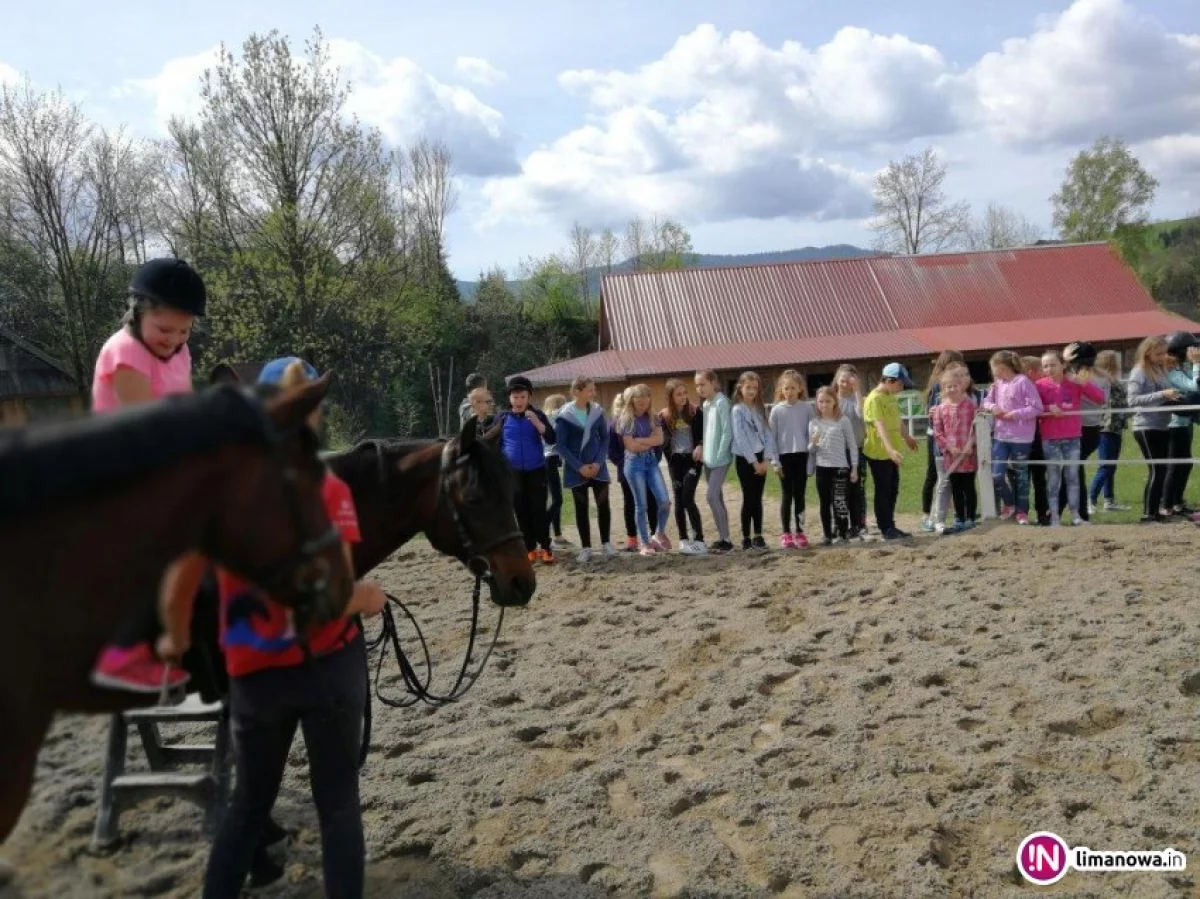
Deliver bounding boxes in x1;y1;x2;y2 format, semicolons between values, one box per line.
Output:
0;385;278;522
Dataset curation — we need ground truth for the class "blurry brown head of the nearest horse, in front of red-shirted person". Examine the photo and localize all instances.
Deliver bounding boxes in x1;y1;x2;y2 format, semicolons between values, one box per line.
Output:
205;374;354;627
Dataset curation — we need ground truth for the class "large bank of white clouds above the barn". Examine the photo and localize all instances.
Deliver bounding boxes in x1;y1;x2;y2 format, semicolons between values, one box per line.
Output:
485;0;1200;231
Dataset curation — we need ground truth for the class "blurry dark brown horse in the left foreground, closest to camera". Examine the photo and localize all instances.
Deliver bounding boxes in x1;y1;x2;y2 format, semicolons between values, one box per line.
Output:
0;379;353;840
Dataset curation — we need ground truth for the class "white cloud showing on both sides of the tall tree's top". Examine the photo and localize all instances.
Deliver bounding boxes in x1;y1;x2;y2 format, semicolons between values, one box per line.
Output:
124;38;516;176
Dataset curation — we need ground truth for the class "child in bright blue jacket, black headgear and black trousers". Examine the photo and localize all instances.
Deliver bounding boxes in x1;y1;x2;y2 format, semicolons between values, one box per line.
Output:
492;374;556;564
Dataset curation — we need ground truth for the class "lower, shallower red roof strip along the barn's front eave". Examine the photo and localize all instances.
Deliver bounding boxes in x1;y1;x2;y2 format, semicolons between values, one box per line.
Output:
524;308;1200;386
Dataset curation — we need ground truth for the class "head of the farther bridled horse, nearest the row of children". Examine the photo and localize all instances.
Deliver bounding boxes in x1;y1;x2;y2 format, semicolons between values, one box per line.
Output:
430;418;538;606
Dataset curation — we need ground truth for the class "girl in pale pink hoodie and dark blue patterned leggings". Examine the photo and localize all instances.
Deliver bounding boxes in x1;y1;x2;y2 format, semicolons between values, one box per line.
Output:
982;349;1042;525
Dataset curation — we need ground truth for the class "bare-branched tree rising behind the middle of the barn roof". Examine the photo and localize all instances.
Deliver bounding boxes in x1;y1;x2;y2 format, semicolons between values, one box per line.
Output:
870;146;971;253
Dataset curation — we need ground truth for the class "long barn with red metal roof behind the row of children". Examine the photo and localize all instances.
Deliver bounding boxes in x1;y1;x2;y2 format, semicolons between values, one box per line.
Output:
524;242;1200;404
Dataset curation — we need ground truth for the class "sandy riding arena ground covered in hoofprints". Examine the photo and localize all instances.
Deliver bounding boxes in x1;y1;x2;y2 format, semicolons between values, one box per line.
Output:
7;495;1200;899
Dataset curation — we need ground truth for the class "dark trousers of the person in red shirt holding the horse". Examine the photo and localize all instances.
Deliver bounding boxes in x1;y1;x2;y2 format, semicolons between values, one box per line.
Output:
204;634;367;899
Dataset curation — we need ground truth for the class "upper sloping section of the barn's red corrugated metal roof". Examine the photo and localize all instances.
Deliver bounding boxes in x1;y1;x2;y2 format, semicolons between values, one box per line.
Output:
601;242;1156;352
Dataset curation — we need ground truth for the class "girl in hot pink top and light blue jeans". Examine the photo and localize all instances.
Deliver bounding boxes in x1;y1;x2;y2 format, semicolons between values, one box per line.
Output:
1038;349;1104;527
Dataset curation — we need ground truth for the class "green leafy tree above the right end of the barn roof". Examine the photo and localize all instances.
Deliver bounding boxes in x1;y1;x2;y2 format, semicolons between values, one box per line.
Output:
1050;137;1158;241
